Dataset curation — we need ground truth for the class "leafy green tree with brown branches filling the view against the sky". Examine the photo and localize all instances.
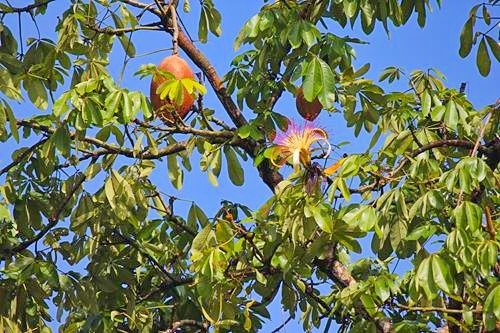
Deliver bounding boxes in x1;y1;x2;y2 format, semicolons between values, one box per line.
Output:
0;0;500;332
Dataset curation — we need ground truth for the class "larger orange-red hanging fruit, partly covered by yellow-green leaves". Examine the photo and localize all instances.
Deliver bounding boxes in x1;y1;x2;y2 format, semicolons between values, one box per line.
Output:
149;54;195;123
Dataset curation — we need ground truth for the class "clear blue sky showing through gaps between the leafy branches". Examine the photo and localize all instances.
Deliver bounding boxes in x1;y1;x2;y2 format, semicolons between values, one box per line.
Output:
0;0;499;332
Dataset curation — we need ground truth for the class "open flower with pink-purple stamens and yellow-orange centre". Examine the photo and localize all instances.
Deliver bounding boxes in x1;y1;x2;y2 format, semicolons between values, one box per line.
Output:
271;122;331;170
